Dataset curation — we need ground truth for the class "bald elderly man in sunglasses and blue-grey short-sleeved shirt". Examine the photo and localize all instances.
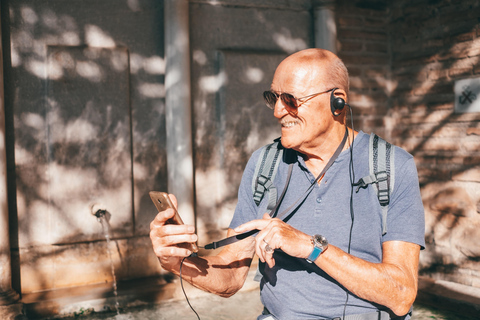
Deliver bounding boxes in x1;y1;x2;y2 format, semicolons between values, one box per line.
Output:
150;49;424;320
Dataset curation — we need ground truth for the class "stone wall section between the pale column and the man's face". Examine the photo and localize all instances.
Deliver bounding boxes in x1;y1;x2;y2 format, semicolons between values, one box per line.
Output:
190;0;313;244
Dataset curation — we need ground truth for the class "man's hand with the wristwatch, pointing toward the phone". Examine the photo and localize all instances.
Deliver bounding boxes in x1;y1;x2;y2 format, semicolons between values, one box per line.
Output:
235;213;313;268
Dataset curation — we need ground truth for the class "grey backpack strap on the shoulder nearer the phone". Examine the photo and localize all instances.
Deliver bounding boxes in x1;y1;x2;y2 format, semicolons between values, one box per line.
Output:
252;139;284;210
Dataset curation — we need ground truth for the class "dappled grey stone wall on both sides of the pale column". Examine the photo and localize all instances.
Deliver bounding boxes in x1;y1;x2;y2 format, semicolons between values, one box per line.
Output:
2;0;313;293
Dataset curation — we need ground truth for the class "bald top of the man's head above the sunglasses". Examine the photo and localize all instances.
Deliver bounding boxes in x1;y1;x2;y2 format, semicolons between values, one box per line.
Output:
277;48;349;94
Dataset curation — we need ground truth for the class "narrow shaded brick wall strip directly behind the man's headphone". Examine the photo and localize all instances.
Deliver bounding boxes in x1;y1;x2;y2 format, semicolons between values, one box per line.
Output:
336;1;390;136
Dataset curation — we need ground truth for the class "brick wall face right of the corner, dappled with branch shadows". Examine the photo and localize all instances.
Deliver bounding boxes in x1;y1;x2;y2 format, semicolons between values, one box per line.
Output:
390;1;480;286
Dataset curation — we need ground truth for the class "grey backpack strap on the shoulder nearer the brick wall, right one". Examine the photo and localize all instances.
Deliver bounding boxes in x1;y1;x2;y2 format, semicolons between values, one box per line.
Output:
354;133;395;234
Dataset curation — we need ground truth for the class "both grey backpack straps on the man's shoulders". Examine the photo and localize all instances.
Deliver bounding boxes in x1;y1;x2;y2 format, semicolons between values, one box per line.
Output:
252;133;395;235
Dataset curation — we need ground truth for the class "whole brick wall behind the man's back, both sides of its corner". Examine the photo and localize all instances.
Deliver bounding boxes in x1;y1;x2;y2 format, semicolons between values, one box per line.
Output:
337;0;480;287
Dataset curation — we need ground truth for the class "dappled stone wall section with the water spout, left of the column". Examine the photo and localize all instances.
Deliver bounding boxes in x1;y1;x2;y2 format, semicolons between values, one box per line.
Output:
2;0;167;293
